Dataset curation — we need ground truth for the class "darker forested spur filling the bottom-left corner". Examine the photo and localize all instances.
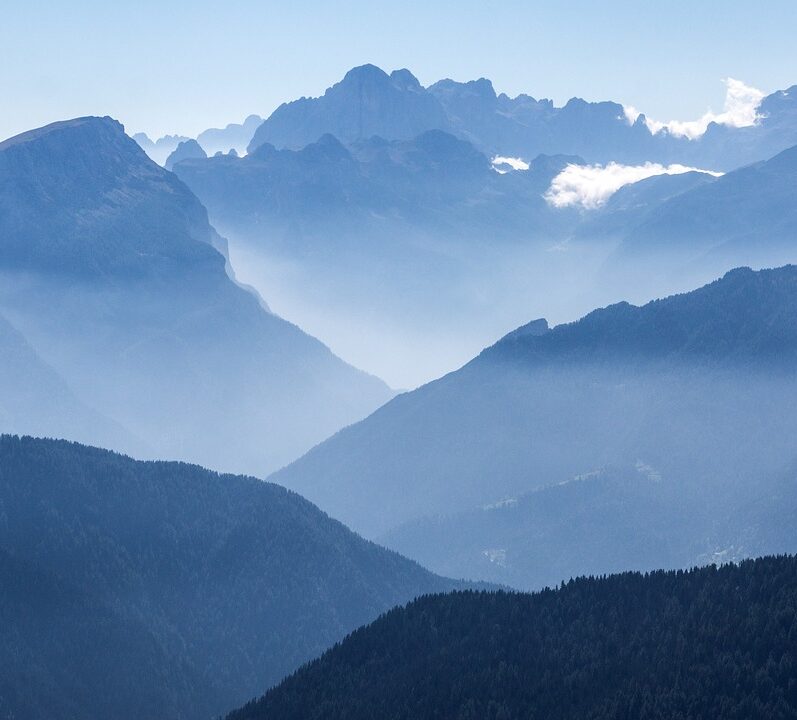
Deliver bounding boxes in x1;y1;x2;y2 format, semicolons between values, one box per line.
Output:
0;548;205;718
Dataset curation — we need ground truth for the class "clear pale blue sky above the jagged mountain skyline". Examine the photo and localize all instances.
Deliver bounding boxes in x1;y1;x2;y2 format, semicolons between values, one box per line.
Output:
0;0;797;138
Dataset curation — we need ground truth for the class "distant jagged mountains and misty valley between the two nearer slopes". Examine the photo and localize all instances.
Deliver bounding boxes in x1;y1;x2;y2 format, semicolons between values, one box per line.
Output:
179;66;797;387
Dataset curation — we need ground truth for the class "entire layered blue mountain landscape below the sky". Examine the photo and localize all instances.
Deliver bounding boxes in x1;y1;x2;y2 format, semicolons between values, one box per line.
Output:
0;65;797;720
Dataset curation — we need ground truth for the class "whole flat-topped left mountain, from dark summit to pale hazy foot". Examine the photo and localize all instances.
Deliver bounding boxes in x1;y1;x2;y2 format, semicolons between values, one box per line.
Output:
0;118;390;472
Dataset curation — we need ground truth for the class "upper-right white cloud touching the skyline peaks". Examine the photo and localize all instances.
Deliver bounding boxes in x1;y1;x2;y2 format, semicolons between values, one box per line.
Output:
623;78;764;140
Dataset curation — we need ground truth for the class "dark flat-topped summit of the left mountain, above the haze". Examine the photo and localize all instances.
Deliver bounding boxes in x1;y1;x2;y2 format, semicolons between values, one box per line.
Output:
0;117;218;277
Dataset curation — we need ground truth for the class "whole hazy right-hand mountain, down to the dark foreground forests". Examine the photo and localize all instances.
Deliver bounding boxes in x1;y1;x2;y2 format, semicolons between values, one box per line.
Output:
274;266;797;586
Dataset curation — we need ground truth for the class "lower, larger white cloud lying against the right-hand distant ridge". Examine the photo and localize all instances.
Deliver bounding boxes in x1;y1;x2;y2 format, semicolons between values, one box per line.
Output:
544;162;722;210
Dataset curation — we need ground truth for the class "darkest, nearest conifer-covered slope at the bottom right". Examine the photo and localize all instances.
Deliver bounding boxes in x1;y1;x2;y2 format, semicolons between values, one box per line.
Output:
228;557;797;720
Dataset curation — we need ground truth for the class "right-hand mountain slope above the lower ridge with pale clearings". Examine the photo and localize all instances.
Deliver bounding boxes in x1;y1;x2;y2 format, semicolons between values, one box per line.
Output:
274;266;797;536
